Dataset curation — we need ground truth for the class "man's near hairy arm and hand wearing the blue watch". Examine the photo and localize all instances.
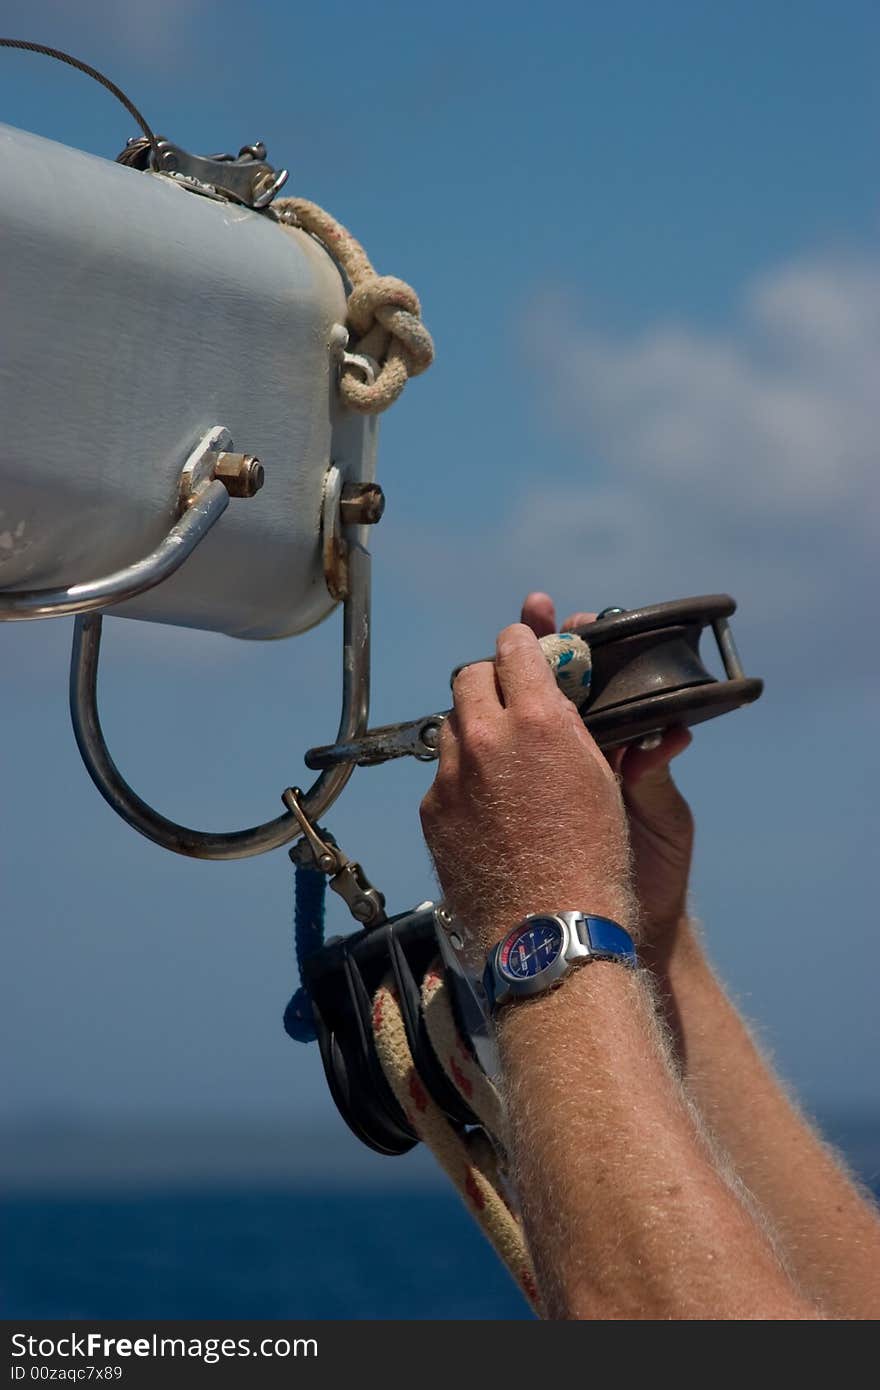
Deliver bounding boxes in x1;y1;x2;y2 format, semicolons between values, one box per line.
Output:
423;627;816;1318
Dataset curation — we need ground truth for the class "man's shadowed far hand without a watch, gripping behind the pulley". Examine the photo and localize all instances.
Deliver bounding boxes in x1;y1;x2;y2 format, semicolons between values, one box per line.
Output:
523;594;694;963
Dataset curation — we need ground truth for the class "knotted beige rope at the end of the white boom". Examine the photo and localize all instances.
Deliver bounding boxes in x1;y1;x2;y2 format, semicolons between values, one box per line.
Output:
272;197;434;416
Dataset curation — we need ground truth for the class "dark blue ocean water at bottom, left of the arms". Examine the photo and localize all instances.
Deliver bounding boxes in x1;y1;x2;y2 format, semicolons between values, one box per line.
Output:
0;1190;531;1319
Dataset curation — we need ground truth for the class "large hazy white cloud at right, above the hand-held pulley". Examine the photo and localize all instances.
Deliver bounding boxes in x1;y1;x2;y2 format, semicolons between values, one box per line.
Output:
506;257;880;656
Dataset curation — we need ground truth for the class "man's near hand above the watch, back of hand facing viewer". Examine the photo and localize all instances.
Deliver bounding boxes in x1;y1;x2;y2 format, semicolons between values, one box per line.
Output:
421;624;634;963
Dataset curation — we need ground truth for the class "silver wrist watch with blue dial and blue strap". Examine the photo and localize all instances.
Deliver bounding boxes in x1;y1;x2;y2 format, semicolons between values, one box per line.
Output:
482;912;638;1012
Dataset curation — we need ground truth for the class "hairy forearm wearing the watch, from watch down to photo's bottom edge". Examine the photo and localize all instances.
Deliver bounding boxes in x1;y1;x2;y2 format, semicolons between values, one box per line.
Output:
499;962;815;1319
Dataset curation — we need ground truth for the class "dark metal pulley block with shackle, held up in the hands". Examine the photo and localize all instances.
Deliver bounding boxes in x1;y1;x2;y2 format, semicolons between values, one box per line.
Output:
306;594;763;769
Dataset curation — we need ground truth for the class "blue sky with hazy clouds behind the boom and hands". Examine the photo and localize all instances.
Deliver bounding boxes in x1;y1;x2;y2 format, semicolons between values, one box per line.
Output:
0;0;880;1173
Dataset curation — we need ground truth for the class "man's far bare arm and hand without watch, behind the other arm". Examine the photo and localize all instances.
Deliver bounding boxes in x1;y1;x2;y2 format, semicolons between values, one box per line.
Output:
523;594;880;1318
